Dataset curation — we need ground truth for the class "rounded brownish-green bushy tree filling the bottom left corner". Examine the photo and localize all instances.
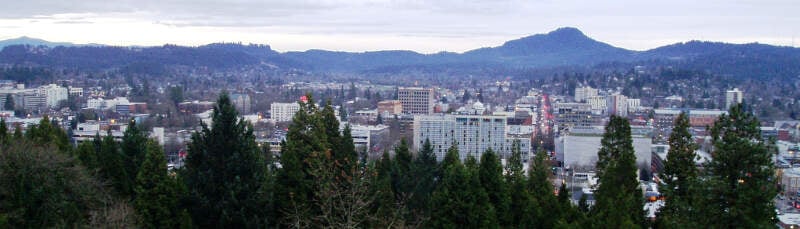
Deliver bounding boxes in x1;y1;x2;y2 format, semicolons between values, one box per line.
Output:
0;141;109;228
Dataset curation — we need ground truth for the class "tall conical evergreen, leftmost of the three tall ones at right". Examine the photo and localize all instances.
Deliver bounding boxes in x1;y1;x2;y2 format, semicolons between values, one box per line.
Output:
591;116;644;228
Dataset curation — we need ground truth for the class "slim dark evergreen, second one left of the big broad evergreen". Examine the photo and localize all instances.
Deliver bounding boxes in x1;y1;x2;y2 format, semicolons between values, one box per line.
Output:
120;120;148;195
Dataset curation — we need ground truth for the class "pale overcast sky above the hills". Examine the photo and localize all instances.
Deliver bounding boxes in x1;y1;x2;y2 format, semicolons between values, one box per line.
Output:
0;0;800;53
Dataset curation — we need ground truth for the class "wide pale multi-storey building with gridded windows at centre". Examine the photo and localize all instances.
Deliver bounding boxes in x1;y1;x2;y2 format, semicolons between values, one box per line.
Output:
413;114;531;161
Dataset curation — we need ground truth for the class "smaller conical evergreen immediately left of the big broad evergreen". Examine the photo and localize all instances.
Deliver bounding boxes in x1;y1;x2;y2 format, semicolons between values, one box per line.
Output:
133;140;181;228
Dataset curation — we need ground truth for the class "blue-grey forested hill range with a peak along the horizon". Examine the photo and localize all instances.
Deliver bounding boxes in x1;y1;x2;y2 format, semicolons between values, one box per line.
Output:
0;27;800;77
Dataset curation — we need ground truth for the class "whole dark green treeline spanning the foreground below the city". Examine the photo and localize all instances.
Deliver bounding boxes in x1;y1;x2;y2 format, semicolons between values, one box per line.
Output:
0;94;776;228
